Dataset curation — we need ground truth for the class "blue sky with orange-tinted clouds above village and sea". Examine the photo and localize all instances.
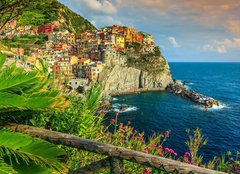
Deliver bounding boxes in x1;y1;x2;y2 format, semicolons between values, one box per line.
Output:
59;0;240;62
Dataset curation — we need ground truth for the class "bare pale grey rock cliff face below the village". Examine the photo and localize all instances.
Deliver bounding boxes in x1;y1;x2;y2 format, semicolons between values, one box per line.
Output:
100;58;172;95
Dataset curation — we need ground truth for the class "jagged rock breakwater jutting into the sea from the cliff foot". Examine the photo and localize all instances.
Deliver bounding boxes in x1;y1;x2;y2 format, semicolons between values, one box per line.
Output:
167;80;223;109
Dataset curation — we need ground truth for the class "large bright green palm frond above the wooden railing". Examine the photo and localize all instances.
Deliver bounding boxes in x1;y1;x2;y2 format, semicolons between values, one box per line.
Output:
0;54;68;113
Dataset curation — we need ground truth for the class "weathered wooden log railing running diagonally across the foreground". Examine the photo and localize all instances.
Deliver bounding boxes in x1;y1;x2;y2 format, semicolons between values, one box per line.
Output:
4;123;227;174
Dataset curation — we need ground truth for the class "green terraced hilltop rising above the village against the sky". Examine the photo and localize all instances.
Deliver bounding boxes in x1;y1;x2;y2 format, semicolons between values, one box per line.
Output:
17;0;95;32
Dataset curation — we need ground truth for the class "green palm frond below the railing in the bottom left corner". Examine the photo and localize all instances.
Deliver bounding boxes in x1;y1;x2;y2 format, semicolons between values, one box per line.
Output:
0;130;65;171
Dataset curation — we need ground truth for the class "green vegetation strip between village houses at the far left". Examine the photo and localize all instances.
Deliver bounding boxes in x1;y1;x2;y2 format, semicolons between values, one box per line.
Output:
2;35;48;55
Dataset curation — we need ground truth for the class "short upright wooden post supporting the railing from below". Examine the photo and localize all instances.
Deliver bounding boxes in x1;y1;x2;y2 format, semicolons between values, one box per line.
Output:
110;157;125;174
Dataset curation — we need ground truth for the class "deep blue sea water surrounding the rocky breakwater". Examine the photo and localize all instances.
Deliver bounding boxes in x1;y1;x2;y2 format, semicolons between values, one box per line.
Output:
108;63;240;161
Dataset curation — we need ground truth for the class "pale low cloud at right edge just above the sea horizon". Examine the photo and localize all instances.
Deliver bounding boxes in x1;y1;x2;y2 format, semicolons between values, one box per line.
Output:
203;38;240;54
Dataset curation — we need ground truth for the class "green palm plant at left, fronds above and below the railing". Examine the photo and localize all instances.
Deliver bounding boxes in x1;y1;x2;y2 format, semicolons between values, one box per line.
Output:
0;54;68;173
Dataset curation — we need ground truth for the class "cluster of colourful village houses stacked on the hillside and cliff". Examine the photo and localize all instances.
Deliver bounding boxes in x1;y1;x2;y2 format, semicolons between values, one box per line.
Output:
1;20;155;89
